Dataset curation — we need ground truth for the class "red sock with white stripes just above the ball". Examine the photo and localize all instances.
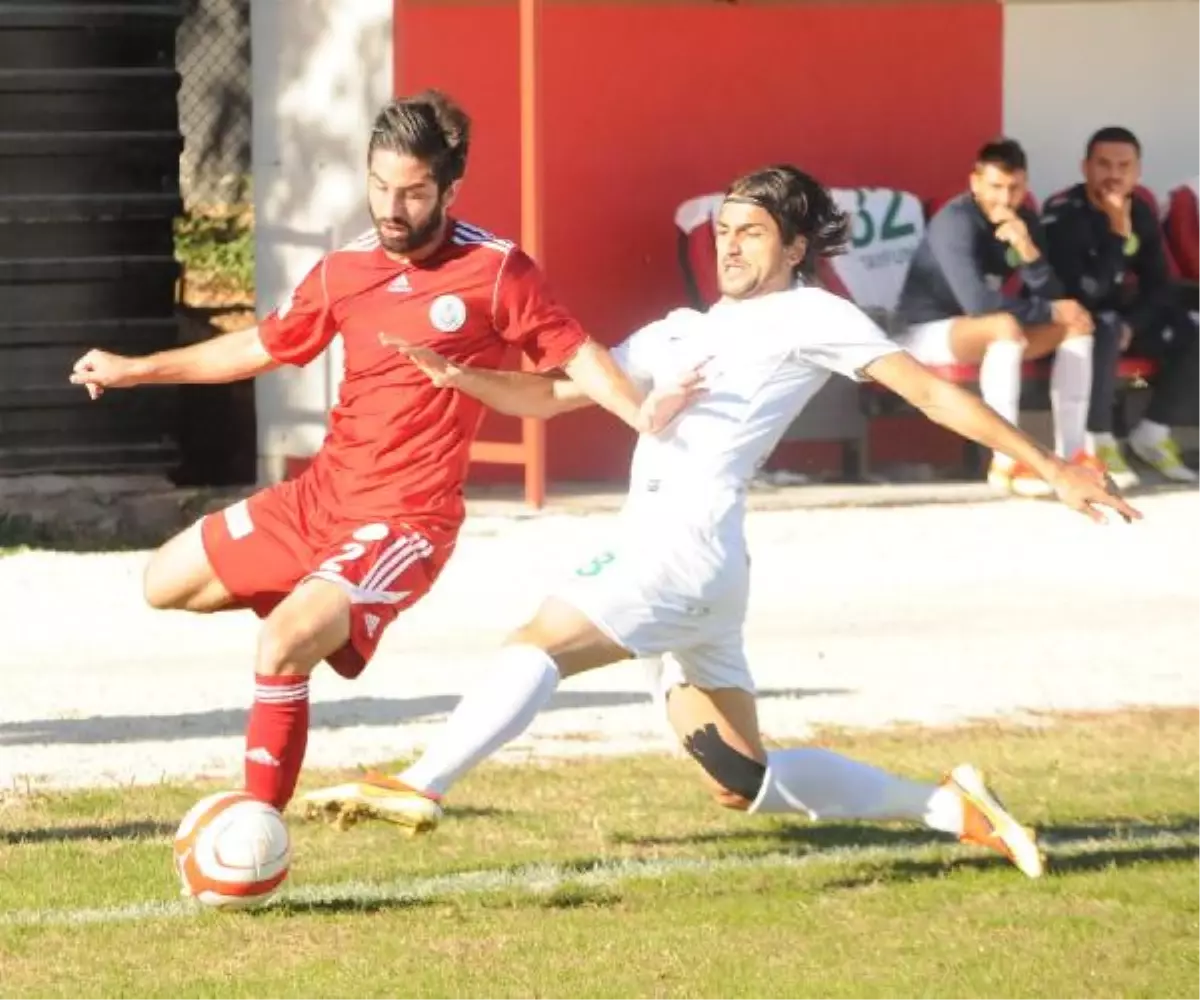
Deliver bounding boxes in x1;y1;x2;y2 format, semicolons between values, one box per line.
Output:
245;673;308;809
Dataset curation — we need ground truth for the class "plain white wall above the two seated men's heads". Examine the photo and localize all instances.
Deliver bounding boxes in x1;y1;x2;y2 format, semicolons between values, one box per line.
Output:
1004;0;1200;204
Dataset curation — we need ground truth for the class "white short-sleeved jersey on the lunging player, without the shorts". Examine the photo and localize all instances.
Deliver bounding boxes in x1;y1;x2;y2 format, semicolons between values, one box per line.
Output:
613;286;900;505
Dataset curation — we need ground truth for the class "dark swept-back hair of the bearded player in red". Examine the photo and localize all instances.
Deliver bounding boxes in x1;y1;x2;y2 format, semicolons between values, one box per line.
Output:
367;90;470;191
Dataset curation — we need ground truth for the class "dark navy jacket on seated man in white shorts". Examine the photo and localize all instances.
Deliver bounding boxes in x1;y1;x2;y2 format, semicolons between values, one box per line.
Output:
896;192;1064;327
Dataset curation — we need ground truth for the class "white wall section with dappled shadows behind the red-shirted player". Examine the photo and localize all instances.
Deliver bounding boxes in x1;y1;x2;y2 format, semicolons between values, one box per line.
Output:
251;0;392;481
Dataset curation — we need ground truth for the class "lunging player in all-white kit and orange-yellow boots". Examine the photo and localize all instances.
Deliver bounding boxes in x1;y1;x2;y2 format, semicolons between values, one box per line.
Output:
302;167;1140;876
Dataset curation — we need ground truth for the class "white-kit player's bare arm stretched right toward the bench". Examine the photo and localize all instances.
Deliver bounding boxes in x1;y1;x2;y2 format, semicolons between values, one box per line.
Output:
864;351;1141;523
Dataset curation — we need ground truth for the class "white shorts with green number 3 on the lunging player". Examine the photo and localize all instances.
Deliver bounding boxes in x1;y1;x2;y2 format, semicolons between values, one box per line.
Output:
554;535;755;694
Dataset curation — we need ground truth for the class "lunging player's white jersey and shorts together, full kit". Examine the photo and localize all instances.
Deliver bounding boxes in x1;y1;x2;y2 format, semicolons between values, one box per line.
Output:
558;287;900;672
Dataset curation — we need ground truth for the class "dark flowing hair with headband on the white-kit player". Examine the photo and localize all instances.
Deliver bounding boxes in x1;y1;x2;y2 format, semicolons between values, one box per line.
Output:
725;163;850;276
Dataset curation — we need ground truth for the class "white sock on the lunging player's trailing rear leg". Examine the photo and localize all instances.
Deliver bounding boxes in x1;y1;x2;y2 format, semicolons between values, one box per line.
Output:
750;747;962;833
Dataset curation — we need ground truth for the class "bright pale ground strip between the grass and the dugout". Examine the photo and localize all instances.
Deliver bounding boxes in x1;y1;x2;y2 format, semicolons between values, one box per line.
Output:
0;484;1200;794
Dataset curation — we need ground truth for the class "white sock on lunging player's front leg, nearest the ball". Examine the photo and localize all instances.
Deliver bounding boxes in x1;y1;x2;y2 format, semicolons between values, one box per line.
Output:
396;646;559;795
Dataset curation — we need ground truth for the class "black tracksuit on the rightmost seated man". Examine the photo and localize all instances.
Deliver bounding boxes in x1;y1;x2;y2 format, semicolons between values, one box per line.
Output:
1043;184;1200;433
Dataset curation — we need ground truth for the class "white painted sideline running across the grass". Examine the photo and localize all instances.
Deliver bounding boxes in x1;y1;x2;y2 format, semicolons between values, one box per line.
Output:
0;831;1200;927
